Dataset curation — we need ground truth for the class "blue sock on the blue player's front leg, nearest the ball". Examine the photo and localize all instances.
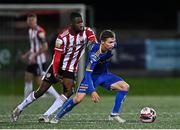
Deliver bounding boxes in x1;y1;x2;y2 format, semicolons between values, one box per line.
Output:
112;91;128;113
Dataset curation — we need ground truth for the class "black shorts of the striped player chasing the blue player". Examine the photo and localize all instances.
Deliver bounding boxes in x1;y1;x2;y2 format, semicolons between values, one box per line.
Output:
42;65;75;84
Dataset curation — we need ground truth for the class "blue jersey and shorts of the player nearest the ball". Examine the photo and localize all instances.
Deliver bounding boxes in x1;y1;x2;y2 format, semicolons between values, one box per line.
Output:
78;43;123;93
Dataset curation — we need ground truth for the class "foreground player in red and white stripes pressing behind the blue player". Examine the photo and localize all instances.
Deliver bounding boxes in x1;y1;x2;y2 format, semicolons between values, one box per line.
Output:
12;12;96;122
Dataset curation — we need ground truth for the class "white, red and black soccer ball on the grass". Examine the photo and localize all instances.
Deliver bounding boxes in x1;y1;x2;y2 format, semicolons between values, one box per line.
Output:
140;107;156;123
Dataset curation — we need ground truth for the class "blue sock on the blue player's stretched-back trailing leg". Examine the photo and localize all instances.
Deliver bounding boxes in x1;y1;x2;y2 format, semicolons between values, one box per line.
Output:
56;99;77;119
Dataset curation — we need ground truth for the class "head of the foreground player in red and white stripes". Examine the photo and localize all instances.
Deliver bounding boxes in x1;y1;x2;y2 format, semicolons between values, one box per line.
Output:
70;12;84;32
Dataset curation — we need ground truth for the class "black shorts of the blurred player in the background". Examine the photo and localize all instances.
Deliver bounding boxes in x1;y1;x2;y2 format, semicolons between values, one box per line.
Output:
26;63;46;76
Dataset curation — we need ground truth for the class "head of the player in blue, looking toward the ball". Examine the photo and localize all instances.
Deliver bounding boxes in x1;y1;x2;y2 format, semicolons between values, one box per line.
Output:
100;30;116;50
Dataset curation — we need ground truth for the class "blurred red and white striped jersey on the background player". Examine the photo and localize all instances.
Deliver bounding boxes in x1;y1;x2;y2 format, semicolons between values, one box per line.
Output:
29;26;46;64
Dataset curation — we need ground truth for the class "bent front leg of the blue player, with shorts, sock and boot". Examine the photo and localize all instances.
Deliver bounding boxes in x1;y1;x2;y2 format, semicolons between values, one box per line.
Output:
95;73;129;123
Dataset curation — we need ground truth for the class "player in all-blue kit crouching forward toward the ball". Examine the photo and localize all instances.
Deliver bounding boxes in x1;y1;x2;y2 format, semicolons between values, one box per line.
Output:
50;30;129;123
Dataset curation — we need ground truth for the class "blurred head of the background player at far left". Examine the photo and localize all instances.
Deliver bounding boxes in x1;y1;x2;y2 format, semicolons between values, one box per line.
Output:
27;13;37;28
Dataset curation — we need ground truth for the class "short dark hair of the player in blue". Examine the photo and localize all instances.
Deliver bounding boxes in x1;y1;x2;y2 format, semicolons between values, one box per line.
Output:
100;30;115;41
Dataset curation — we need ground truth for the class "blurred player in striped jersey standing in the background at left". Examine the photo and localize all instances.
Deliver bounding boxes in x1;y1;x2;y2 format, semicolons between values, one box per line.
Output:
22;14;58;99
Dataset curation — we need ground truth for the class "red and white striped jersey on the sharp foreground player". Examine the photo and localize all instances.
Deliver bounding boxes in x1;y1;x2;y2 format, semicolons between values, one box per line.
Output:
55;27;97;72
